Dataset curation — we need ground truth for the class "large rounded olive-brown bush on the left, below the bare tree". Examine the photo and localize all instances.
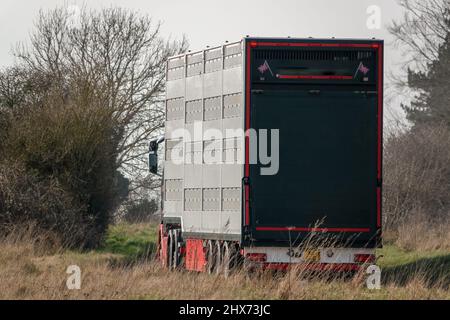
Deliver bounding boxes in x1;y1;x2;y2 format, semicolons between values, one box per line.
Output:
0;83;127;247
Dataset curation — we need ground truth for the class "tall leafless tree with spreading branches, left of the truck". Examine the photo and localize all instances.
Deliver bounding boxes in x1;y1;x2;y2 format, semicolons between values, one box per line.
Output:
15;7;187;198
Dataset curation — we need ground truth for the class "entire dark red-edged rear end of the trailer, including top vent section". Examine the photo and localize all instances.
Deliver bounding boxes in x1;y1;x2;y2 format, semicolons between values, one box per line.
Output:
244;40;382;246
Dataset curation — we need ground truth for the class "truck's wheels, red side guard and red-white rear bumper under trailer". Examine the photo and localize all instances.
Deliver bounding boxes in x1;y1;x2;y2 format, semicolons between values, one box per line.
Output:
158;224;375;275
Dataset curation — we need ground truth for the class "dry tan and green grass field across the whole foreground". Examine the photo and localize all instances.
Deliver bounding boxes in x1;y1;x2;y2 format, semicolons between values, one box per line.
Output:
0;224;450;299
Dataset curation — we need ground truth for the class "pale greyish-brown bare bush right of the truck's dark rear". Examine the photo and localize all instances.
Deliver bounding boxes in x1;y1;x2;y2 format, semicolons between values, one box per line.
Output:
383;125;450;230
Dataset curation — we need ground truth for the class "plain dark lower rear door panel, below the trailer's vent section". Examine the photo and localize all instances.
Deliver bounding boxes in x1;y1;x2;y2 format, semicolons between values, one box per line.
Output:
250;90;377;244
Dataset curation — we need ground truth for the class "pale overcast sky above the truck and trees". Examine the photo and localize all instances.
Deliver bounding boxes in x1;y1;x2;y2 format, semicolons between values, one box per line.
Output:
0;0;403;120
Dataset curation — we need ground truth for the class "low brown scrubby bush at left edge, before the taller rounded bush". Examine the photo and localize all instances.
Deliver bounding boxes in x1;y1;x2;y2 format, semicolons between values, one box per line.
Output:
0;163;87;247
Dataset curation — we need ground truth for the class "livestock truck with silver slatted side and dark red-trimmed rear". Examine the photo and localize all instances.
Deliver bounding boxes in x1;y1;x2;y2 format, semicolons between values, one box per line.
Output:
149;36;384;274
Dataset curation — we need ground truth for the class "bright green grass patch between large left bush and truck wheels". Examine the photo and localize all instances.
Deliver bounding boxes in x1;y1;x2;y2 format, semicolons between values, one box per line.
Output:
100;223;157;259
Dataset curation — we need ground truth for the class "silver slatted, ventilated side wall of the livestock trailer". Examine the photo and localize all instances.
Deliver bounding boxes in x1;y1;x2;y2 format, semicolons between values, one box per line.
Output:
163;41;244;238
